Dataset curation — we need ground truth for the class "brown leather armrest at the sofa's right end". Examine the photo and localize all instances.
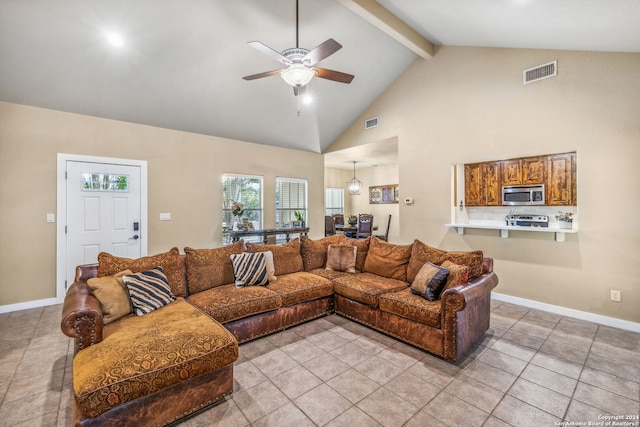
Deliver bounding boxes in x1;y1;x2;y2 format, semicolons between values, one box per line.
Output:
442;260;498;360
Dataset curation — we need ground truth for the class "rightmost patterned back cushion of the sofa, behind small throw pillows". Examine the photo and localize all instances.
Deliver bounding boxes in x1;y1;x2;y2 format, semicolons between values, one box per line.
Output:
407;239;483;283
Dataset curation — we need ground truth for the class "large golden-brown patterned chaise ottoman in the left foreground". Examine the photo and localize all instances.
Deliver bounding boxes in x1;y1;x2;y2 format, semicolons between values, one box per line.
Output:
73;298;238;426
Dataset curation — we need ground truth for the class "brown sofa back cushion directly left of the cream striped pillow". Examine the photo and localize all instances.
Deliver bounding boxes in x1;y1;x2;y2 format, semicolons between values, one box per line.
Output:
184;240;244;294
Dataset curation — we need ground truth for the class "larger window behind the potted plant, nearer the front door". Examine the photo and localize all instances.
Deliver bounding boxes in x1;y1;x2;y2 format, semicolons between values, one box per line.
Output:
222;174;263;244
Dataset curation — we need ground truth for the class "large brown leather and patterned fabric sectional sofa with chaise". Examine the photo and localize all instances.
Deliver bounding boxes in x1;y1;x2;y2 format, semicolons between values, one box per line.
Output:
62;235;498;425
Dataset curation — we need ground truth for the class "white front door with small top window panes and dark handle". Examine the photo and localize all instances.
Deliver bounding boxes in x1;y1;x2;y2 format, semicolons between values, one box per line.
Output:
58;155;147;299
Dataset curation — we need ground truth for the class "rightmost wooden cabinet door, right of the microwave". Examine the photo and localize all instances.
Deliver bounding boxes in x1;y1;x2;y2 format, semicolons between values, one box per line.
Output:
546;153;575;206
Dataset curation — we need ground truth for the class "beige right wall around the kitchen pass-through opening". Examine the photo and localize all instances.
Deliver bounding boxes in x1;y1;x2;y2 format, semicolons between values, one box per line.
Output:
330;47;640;322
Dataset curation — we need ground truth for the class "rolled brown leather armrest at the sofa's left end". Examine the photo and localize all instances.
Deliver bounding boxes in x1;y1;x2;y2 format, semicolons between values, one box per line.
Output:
60;267;104;353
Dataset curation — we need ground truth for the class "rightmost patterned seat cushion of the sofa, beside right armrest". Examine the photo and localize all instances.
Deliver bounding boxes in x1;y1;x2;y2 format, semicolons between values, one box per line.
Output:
380;288;442;329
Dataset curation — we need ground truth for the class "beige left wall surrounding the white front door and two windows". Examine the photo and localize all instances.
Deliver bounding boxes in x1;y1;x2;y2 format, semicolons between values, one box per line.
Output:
0;102;324;306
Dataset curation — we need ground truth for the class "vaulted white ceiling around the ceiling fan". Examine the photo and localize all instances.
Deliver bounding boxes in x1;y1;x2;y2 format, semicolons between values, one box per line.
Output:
0;0;640;157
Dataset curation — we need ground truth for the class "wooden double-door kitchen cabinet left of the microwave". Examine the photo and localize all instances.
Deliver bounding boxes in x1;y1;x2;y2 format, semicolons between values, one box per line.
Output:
464;162;502;206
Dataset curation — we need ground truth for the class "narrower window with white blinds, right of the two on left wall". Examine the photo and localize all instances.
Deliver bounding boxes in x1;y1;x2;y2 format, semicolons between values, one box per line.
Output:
276;178;308;227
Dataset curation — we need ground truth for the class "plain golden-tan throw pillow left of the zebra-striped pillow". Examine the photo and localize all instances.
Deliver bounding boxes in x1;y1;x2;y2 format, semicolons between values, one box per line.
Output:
87;270;133;325
